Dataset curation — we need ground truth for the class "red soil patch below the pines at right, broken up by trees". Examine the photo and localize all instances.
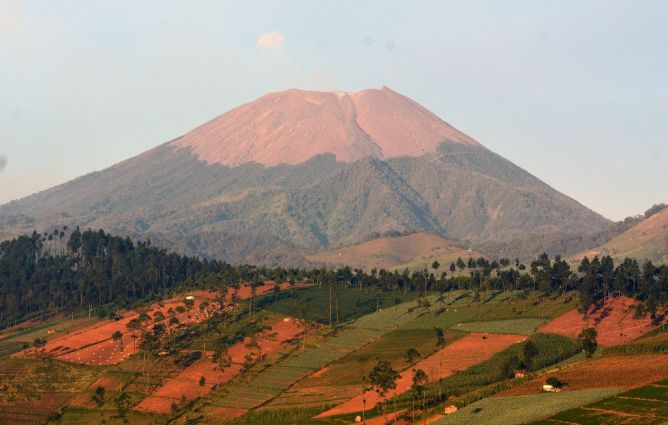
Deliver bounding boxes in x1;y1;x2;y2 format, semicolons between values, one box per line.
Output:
538;296;656;347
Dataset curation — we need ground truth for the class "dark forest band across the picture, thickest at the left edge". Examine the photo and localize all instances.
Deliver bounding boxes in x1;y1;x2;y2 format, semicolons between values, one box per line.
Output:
0;228;668;327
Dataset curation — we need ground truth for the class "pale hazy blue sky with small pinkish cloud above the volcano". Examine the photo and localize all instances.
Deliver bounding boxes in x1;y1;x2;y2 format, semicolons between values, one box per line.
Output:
0;0;668;219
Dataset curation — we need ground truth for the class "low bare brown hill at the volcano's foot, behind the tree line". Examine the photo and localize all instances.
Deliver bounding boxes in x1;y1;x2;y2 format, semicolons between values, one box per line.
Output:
306;233;480;271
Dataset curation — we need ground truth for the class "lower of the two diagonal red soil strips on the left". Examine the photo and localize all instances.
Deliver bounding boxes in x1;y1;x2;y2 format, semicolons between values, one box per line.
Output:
135;318;303;414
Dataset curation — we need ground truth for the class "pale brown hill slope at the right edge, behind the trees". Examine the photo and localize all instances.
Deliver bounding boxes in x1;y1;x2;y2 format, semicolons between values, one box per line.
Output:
574;208;668;263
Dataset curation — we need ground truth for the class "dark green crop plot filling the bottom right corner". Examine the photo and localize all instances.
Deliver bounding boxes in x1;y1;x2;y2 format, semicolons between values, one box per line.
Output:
535;380;668;425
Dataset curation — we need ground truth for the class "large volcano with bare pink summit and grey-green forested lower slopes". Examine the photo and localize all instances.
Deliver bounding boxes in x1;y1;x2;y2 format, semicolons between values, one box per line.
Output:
0;88;609;264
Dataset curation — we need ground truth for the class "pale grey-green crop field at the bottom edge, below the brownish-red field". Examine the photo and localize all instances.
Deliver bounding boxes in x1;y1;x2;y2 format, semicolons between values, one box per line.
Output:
433;388;623;425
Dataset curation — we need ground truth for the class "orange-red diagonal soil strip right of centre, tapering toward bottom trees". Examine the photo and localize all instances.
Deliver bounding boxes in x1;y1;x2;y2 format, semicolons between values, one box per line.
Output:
316;333;526;418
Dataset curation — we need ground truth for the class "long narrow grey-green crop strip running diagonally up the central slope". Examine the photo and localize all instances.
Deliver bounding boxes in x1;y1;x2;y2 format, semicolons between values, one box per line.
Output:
206;296;444;409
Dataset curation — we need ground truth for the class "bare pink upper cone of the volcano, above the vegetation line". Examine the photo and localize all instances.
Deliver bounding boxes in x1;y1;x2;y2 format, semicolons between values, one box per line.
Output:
172;86;481;167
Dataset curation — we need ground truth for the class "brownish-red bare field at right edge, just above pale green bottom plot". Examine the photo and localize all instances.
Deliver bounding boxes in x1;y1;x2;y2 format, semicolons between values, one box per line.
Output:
496;354;668;397
